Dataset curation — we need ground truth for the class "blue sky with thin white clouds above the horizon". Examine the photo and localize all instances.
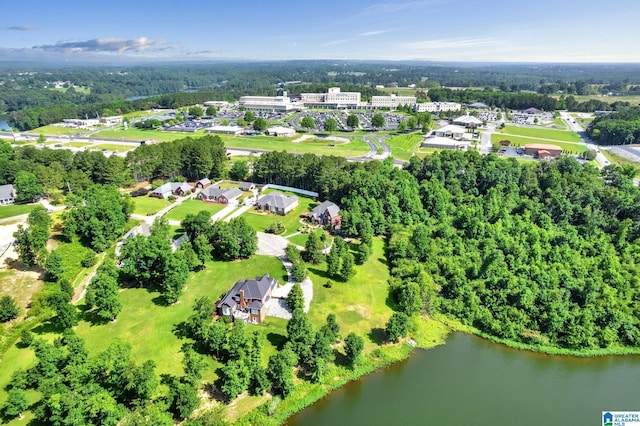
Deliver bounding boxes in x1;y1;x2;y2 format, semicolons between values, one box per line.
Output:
0;0;640;62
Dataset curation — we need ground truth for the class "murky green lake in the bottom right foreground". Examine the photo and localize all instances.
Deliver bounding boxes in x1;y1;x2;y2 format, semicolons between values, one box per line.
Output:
286;333;640;426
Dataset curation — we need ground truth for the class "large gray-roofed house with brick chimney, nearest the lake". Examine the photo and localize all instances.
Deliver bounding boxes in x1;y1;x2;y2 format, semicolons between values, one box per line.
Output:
216;274;278;324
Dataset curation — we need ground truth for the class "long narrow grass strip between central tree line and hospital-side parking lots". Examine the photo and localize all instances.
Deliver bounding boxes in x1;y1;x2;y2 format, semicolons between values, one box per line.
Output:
221;134;369;157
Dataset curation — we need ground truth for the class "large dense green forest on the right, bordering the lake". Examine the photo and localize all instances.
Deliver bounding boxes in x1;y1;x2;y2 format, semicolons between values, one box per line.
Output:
250;151;640;349
